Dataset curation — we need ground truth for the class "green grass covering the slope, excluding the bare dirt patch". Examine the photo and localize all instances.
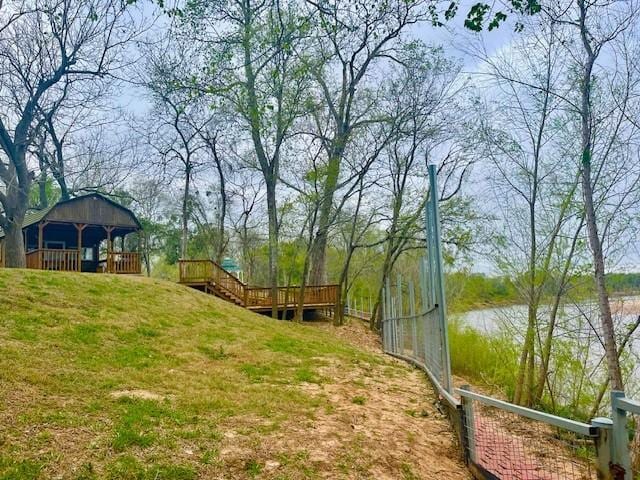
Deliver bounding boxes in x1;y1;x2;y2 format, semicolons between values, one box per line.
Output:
0;269;386;480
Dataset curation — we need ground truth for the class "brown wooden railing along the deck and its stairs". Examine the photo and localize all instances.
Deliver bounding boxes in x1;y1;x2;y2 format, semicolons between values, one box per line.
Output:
179;260;338;312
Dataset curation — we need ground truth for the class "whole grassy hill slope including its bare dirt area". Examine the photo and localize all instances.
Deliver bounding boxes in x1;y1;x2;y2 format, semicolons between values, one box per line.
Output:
0;269;465;480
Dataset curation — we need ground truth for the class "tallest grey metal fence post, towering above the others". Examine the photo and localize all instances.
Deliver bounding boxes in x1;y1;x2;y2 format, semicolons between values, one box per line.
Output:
428;165;452;393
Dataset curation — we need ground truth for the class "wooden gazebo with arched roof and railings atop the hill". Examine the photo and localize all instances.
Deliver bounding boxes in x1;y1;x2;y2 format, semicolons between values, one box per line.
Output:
0;193;142;274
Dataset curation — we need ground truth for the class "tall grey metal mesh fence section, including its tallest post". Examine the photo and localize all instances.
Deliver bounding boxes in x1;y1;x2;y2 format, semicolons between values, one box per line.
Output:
382;165;452;393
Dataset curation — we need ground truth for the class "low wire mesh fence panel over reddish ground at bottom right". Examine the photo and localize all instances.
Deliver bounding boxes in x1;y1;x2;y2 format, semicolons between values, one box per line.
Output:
463;390;598;480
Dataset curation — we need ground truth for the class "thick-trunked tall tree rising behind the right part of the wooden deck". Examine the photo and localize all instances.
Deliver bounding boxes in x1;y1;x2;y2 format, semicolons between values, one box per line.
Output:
305;0;427;284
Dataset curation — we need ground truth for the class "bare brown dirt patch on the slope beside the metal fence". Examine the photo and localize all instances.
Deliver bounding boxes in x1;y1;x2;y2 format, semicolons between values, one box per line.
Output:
296;320;471;479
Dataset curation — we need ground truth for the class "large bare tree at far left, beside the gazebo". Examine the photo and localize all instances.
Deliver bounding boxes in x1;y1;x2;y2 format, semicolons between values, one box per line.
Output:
0;0;141;267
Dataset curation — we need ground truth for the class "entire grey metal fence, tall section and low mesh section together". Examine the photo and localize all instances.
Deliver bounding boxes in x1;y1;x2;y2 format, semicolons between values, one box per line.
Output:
382;166;640;480
